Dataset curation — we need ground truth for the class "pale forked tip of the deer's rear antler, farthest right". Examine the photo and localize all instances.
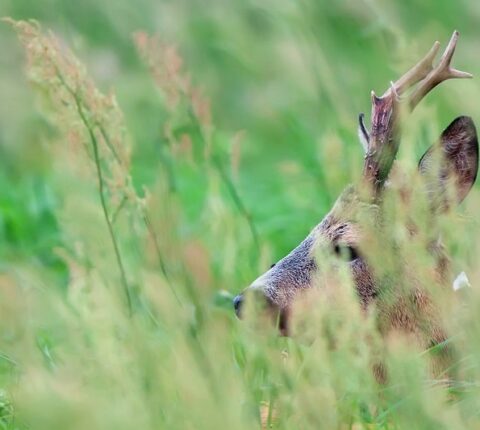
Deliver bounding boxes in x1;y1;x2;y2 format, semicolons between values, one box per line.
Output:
409;30;473;110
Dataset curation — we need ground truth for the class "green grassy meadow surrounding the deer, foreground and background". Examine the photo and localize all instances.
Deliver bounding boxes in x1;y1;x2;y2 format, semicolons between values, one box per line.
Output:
0;0;480;430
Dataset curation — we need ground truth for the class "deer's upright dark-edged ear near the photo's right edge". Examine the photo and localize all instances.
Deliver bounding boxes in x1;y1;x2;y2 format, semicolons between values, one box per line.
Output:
418;116;478;211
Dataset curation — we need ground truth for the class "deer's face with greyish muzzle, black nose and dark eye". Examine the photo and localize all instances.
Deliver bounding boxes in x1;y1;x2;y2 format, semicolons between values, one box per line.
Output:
235;187;377;323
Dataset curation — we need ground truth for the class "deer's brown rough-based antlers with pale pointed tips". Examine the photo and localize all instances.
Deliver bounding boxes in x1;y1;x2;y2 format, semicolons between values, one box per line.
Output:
359;31;472;194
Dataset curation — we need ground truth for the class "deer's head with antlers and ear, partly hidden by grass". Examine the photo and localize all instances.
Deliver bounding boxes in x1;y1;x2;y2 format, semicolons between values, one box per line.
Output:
234;31;478;350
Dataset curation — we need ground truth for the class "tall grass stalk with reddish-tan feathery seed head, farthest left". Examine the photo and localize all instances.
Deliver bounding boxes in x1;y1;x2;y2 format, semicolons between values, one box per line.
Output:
8;20;139;312
